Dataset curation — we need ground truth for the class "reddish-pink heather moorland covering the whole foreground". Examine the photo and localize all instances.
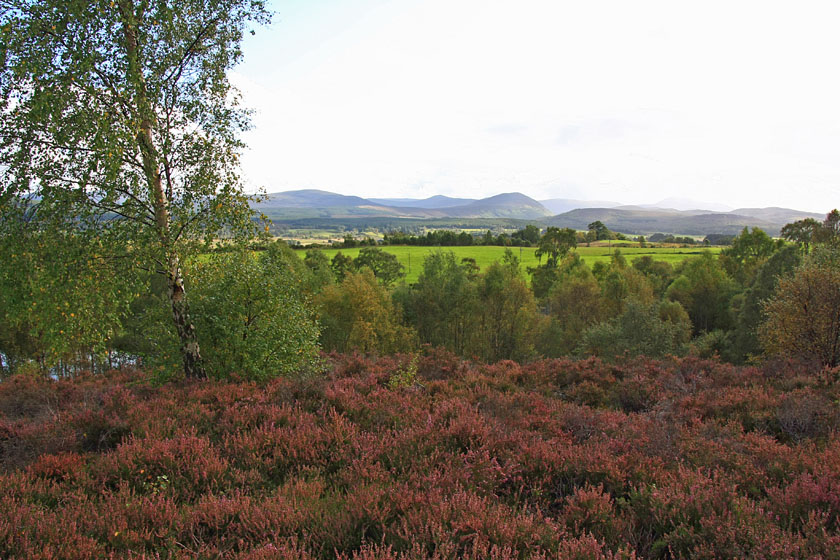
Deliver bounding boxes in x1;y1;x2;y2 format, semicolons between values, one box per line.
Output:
0;350;840;560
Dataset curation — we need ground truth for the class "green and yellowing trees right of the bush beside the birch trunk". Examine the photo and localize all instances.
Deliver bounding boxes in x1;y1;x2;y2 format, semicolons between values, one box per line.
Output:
296;211;840;365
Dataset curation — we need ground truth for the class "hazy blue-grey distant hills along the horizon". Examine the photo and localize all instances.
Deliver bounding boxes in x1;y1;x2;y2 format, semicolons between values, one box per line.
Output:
254;189;824;235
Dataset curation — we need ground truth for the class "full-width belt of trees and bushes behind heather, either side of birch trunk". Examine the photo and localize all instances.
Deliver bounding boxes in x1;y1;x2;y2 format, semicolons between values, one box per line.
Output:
0;211;840;378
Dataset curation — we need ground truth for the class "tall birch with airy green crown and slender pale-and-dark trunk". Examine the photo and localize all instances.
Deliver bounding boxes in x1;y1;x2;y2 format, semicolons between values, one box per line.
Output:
0;0;270;377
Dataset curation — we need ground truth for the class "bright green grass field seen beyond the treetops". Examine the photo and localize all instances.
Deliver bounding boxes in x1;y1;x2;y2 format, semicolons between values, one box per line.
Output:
297;245;721;284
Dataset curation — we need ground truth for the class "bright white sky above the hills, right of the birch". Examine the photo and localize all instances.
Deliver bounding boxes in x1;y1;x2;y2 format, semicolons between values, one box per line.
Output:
231;0;840;213
